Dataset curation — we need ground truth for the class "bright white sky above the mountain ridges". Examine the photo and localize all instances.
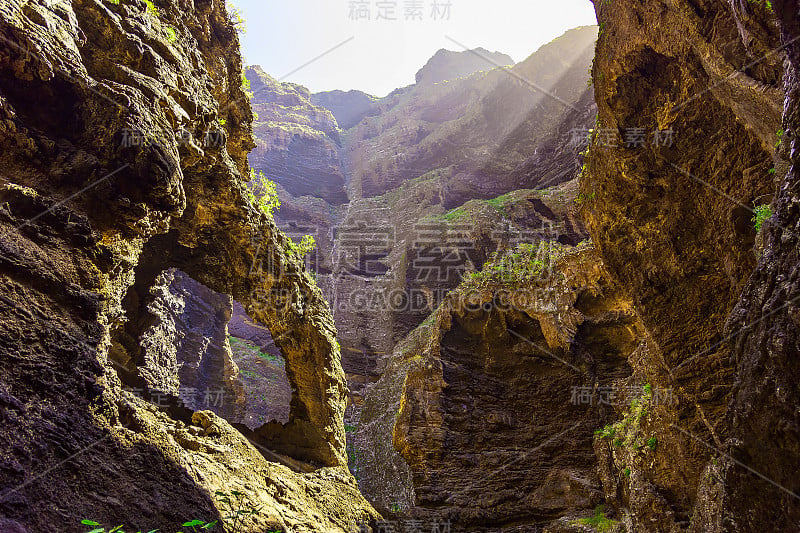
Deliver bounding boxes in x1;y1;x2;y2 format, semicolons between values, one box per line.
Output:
229;0;597;96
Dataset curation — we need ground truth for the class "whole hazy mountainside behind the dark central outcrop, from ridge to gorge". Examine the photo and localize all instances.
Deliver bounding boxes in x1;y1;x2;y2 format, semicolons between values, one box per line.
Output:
320;28;596;392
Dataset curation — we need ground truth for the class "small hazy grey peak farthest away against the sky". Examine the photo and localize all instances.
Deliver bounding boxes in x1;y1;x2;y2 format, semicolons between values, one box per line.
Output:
416;48;514;85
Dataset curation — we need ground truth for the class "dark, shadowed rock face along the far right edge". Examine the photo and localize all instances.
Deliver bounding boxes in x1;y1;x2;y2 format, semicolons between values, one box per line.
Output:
716;1;800;531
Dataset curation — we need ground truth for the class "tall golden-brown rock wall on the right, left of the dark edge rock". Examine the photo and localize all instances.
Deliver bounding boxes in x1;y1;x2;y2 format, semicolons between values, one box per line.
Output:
581;0;797;531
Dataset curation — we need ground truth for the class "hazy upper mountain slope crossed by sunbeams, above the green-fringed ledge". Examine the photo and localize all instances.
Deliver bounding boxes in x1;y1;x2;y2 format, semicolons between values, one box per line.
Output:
344;26;597;207
